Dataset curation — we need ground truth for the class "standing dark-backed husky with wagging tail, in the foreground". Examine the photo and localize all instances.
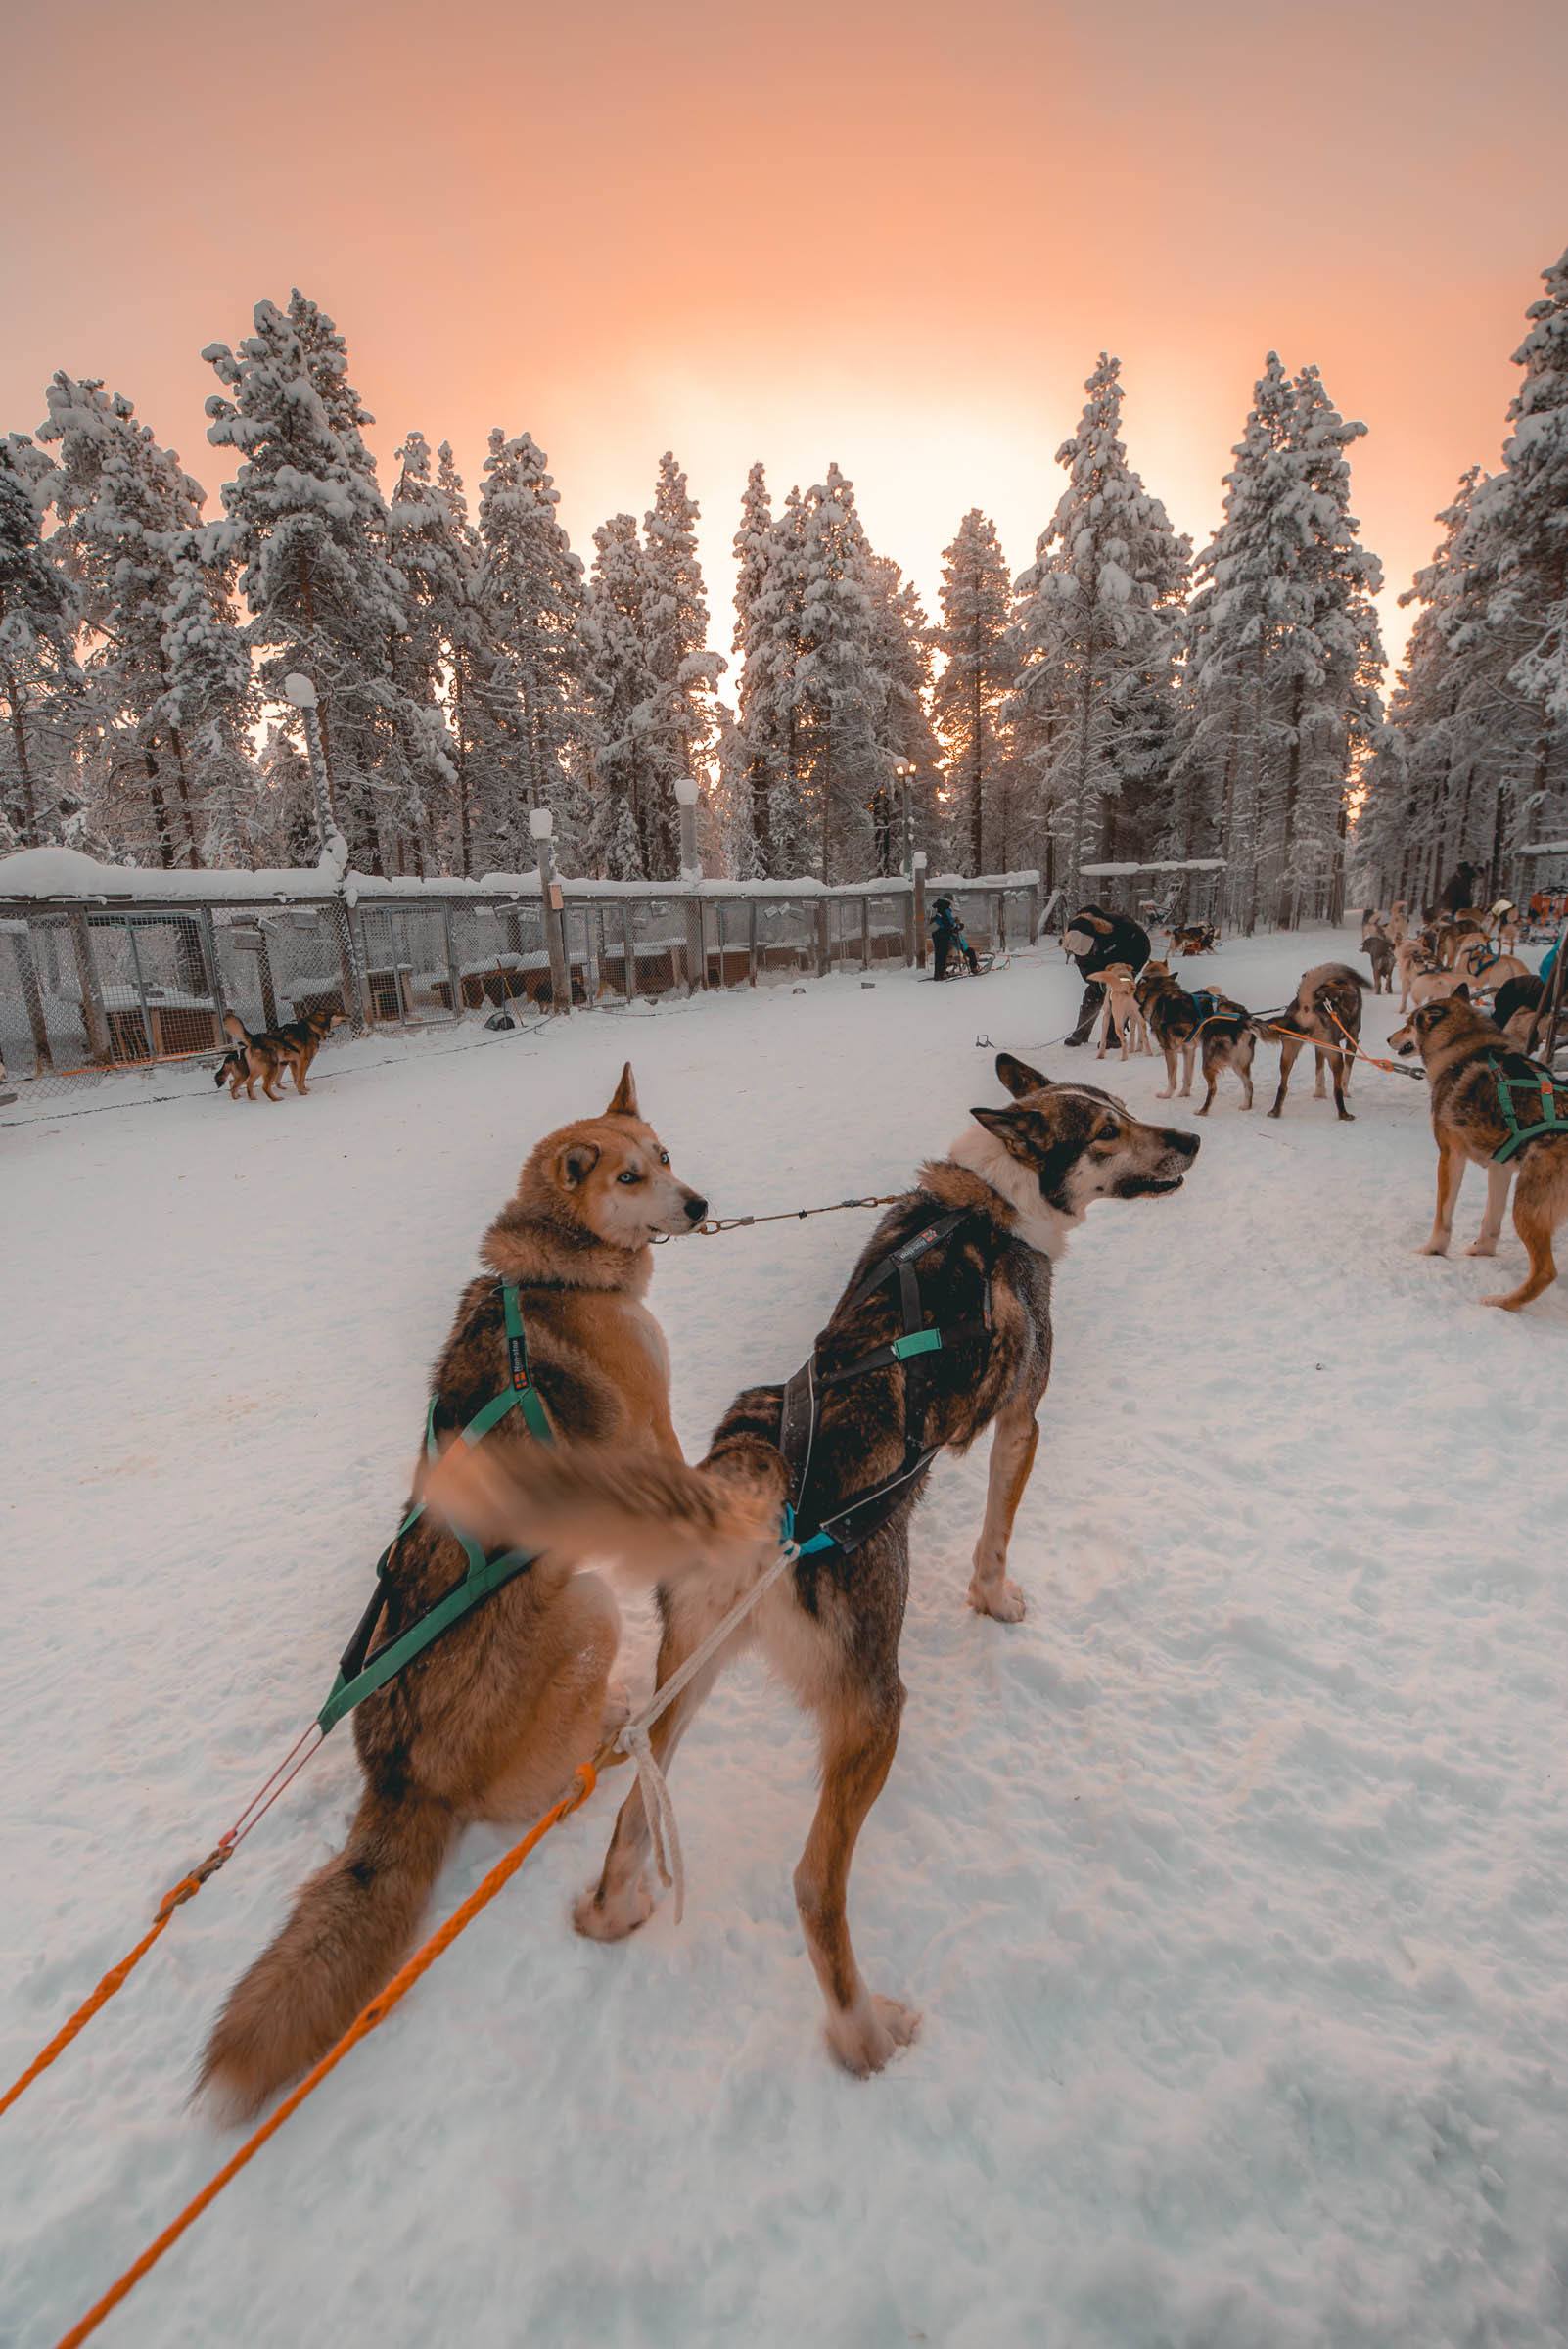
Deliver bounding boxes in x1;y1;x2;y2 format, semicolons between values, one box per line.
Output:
432;1052;1197;2074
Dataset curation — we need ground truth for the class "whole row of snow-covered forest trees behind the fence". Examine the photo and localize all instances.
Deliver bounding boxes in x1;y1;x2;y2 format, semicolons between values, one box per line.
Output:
0;256;1568;928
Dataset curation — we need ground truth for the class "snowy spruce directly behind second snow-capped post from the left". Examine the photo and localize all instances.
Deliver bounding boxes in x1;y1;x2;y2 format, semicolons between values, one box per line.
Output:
479;428;591;871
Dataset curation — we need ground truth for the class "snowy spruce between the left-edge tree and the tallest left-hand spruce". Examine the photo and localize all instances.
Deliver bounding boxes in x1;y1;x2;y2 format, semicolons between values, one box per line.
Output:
37;371;225;867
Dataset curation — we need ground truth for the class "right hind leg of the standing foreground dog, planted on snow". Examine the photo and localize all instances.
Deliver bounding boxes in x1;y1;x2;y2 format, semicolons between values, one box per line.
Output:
796;1658;918;2079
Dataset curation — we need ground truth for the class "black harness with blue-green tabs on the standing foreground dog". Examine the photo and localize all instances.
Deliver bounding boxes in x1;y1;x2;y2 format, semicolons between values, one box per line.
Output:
779;1208;991;1557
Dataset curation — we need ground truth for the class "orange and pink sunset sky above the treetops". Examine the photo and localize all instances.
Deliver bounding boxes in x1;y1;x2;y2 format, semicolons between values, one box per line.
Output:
0;0;1568;671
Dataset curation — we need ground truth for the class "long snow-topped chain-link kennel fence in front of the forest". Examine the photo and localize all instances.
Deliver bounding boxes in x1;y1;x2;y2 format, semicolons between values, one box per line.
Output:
0;873;1039;1102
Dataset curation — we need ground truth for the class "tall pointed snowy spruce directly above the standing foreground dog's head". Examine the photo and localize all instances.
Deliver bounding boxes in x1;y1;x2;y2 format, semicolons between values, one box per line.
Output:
1004;352;1190;893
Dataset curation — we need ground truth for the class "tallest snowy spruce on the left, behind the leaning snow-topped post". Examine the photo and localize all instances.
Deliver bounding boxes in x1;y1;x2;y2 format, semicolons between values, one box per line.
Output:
202;300;418;871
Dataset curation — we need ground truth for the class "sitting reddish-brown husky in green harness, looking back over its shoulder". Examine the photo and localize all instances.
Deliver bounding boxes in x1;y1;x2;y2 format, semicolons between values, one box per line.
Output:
200;1067;707;2114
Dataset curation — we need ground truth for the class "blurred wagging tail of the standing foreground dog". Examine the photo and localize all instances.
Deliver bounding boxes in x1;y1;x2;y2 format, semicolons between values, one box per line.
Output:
425;1445;786;1586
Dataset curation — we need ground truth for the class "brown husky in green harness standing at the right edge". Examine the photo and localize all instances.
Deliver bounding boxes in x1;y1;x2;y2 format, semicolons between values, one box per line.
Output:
1390;989;1568;1313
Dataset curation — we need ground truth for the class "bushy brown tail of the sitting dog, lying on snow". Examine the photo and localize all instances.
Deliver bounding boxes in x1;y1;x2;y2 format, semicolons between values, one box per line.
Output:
197;1795;455;2121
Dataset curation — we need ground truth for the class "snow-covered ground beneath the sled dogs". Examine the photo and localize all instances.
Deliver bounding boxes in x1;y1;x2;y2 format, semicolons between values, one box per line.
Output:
0;938;1568;2349
